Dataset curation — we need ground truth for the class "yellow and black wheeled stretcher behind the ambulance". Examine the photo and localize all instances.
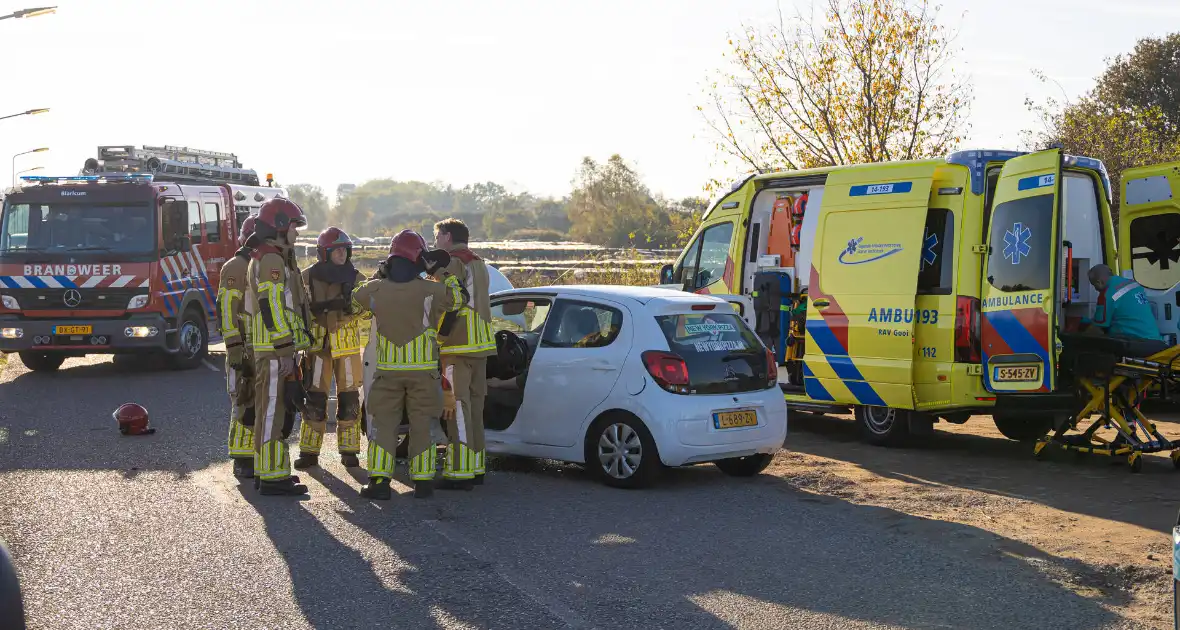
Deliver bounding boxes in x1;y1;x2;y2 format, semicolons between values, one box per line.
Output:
1034;335;1180;472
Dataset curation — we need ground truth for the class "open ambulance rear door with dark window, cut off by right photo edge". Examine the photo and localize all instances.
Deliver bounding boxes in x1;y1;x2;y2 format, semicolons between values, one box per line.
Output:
1113;162;1180;346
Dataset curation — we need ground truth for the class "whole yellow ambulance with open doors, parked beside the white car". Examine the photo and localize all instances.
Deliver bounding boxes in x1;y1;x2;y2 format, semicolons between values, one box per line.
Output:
661;149;1180;444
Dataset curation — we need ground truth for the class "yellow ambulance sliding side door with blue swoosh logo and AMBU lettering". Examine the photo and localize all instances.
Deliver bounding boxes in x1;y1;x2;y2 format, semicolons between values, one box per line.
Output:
804;160;943;409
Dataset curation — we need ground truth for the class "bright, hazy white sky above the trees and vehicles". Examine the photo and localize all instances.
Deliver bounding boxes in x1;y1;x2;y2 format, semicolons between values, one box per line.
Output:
0;0;1180;202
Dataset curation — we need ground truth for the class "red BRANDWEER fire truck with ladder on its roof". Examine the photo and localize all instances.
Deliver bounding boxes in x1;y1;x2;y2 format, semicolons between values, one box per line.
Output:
0;146;286;372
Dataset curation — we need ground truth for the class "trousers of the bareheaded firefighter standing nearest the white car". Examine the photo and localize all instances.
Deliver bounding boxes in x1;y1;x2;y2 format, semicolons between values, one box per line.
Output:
443;355;487;479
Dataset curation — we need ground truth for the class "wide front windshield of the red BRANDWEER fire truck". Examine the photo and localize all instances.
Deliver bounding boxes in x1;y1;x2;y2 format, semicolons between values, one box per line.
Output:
0;202;156;256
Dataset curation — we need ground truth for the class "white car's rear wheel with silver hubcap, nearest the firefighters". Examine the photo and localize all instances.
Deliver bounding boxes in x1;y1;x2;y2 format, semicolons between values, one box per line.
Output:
585;414;663;488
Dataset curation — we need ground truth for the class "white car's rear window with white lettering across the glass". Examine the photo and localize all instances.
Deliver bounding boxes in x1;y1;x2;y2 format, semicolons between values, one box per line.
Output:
656;313;769;394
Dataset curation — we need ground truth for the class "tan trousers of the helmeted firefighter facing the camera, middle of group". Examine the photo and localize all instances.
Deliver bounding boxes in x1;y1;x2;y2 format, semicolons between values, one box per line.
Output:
299;349;365;455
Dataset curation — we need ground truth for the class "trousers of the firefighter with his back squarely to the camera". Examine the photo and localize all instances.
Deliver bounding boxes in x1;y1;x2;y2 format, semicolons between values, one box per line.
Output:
366;369;443;481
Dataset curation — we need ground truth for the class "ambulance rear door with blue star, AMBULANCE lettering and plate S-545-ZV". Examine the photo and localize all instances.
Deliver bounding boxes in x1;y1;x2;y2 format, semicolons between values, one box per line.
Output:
979;149;1062;393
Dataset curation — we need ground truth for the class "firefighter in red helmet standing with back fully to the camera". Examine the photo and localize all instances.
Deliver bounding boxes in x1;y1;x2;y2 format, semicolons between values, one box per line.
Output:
355;230;464;499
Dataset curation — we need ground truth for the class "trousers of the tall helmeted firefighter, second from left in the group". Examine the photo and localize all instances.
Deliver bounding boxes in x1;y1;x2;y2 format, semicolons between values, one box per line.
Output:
254;357;294;481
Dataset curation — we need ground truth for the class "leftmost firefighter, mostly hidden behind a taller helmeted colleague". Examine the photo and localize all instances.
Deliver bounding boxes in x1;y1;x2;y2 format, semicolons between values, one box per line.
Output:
217;216;254;479
